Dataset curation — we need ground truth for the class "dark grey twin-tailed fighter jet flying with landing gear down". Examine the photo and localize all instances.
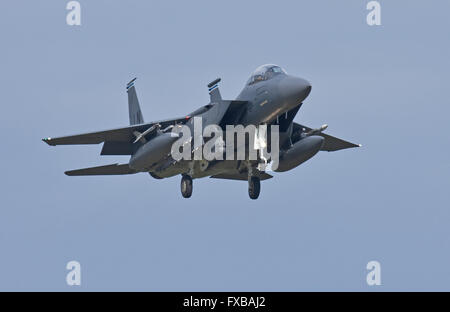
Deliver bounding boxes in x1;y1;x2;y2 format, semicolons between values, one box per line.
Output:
43;65;361;199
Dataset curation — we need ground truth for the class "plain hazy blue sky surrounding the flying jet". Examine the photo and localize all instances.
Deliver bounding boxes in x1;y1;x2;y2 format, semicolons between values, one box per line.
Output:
0;0;450;291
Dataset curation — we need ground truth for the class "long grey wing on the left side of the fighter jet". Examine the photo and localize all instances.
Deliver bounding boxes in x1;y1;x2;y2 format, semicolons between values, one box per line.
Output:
42;117;186;146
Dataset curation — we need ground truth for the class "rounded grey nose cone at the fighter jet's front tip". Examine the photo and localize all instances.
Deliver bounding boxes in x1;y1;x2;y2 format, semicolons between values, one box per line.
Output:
280;76;311;107
